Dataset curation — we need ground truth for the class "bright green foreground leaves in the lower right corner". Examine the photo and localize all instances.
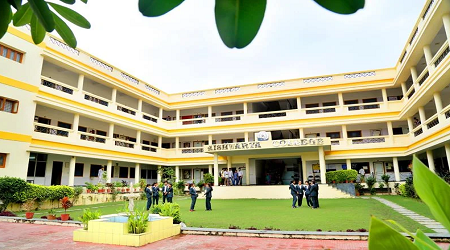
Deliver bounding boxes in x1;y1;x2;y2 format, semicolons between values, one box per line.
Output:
369;157;450;250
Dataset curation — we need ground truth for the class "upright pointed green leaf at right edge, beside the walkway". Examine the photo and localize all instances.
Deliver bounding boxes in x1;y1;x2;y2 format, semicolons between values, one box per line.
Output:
413;157;450;230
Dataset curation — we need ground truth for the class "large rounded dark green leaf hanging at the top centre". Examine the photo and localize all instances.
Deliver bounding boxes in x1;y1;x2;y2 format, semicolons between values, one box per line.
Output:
214;0;267;49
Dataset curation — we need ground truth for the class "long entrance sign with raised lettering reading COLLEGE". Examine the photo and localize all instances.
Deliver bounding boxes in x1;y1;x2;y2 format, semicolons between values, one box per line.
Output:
203;137;331;155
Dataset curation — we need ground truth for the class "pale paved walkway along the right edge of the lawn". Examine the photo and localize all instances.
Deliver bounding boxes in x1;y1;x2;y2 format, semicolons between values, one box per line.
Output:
372;197;448;233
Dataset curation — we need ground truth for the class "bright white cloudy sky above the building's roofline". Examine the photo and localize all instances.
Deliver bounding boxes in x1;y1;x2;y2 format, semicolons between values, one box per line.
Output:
67;0;425;93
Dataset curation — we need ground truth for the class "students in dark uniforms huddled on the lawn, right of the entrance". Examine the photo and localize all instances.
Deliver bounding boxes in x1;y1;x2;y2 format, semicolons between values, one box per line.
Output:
289;180;319;209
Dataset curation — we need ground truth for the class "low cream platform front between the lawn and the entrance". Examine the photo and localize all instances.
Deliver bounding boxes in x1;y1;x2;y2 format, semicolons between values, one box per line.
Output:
206;184;352;199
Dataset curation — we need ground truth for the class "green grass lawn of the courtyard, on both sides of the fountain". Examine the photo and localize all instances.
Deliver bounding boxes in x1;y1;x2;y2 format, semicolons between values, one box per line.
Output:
14;197;433;232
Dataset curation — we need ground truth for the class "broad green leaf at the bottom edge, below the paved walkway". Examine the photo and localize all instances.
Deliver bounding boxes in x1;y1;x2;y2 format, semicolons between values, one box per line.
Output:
369;216;419;250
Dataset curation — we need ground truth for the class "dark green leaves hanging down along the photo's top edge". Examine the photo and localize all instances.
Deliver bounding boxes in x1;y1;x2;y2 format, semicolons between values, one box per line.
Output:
0;0;365;49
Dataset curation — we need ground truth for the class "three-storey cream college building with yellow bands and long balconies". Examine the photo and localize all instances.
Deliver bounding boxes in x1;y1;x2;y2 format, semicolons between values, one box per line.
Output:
0;0;450;193
